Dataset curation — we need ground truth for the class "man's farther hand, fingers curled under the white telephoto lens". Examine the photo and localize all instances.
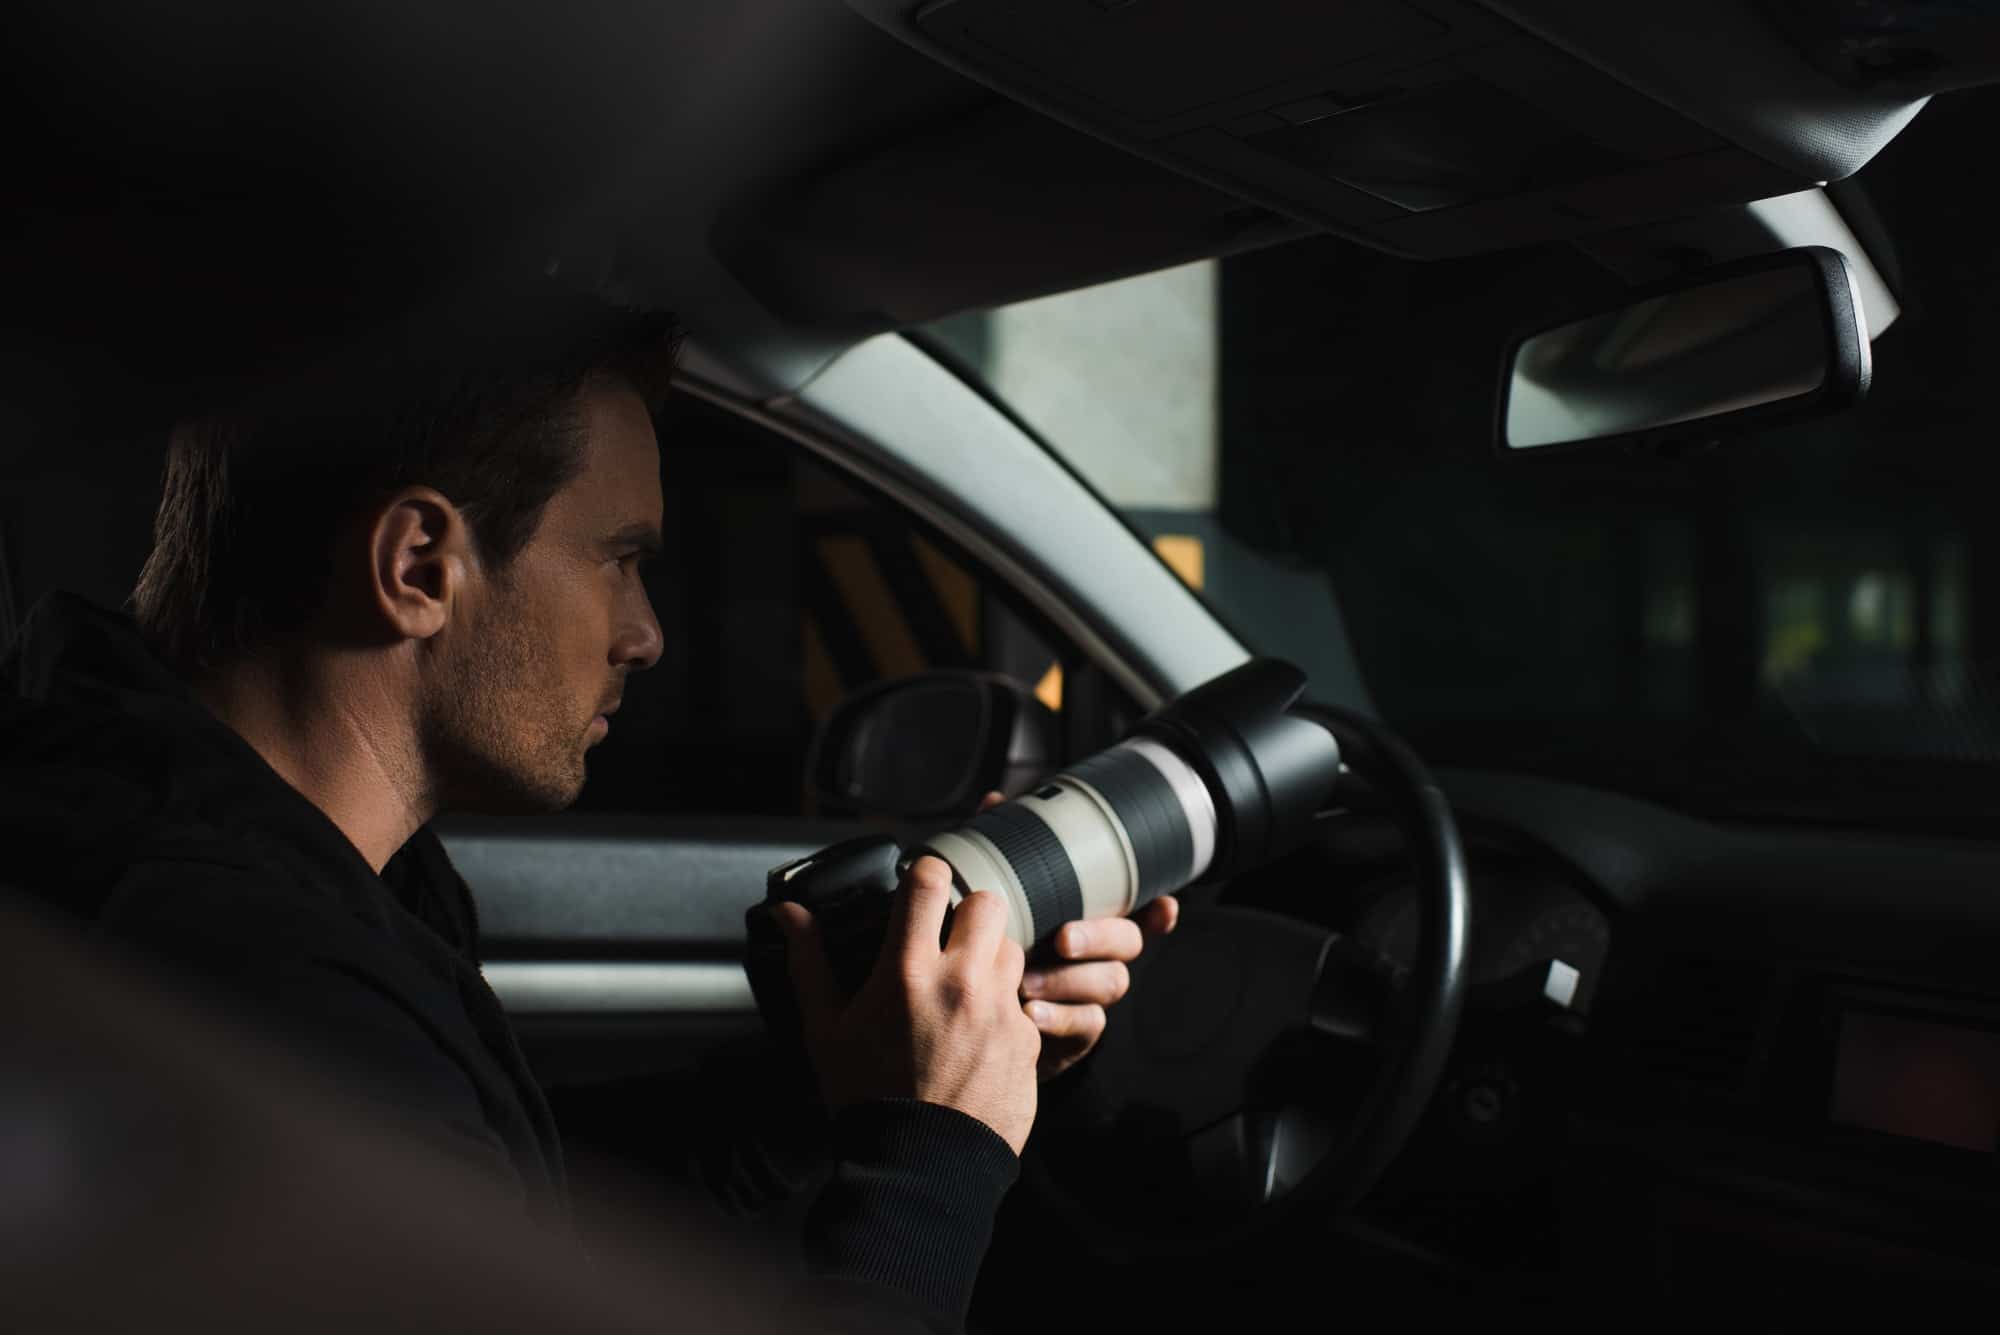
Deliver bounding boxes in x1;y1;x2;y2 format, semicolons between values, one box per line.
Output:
980;793;1180;1079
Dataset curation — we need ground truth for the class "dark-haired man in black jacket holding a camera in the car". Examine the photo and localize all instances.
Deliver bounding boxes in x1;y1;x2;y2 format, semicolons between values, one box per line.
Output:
0;279;1176;1325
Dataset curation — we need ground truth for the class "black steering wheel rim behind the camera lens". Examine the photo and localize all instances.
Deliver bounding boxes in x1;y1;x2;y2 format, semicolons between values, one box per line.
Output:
1022;703;1472;1263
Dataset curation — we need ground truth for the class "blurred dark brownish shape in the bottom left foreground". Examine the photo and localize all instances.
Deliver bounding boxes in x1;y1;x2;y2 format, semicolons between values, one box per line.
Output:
0;891;788;1335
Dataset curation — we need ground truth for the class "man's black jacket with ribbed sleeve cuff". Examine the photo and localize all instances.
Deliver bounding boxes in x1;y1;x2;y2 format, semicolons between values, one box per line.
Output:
0;594;1016;1329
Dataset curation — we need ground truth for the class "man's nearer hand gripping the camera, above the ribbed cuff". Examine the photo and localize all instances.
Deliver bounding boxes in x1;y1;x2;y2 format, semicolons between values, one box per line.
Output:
778;857;1042;1155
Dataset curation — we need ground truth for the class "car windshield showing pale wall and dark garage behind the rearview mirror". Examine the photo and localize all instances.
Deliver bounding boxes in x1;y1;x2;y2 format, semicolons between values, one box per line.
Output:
930;88;2000;837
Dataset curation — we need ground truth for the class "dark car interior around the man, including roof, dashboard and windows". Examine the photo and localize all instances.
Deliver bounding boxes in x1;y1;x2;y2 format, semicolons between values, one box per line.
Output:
11;0;2000;1331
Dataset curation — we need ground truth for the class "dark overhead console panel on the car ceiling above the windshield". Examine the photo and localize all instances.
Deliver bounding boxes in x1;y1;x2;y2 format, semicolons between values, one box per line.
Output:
850;0;1920;258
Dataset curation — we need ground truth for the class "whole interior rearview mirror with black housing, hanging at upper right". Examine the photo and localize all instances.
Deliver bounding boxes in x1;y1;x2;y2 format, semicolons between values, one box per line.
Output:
1498;246;1868;452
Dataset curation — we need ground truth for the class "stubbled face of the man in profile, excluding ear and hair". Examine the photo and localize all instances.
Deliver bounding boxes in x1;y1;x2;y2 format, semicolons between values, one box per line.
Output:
420;380;662;811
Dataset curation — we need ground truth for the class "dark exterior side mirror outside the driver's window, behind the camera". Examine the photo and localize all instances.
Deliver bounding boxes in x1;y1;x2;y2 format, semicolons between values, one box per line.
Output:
806;669;1062;819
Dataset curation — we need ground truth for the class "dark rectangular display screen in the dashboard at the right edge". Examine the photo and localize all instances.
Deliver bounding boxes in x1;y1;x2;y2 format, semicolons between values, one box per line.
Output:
1830;1011;2000;1151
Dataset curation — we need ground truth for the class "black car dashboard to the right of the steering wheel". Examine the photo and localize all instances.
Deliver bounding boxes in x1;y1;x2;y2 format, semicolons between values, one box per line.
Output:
1248;775;2000;1315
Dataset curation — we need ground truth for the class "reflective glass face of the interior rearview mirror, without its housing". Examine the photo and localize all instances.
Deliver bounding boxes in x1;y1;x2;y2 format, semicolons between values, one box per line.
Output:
1504;264;1832;450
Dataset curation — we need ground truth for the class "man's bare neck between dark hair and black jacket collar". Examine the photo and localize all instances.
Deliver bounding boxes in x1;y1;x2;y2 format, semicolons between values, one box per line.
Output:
194;656;432;871
